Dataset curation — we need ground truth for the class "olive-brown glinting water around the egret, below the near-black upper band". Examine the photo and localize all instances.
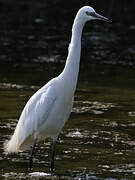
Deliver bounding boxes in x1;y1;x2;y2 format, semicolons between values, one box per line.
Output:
0;63;135;180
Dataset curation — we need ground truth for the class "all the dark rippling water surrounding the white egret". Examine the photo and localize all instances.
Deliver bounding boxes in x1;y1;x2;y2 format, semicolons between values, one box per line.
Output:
0;0;135;180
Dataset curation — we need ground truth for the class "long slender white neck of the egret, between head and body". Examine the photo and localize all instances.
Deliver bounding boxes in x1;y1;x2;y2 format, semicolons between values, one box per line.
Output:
60;16;84;93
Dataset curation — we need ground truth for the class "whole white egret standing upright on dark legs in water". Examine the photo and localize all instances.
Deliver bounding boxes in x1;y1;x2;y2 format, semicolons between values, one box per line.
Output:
4;6;110;171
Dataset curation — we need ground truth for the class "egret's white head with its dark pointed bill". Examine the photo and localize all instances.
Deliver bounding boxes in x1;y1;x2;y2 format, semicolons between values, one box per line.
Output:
78;6;111;22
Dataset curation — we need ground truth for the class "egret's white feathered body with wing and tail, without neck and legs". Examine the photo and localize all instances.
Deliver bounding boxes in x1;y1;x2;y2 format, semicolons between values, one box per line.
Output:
4;78;73;152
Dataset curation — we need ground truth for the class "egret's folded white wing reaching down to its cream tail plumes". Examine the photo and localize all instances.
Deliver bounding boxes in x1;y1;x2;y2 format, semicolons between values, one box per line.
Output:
5;86;56;153
